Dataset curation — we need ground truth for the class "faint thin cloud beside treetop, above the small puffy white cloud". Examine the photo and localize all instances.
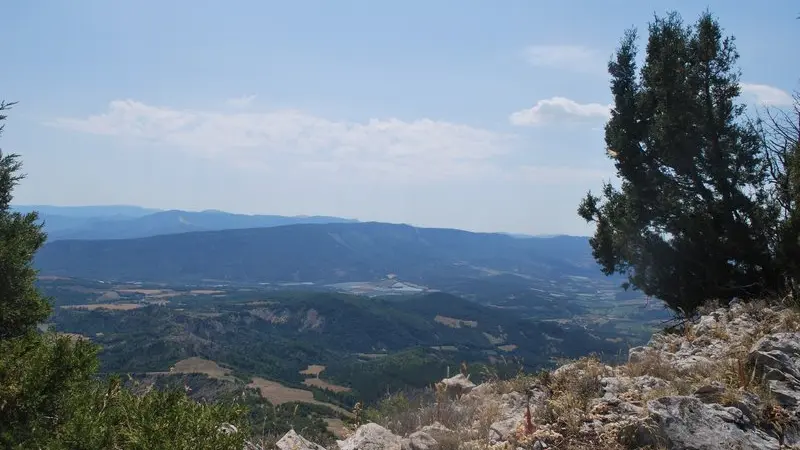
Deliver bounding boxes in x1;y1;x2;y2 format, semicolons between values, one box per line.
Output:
525;45;606;73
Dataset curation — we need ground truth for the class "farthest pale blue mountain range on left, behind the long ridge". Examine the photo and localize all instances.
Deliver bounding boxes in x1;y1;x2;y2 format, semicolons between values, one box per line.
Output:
14;205;357;241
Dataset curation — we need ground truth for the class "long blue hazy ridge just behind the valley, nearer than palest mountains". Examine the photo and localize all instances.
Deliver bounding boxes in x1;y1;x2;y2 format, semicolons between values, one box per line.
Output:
35;223;601;285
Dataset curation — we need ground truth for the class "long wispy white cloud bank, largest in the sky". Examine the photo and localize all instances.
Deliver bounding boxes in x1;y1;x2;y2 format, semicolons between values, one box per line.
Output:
52;100;515;181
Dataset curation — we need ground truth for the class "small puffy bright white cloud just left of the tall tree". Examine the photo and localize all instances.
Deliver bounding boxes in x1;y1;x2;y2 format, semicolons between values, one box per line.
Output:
509;97;611;126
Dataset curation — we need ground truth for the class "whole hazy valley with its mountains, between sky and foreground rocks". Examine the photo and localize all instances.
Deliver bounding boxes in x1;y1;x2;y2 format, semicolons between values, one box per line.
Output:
20;205;669;440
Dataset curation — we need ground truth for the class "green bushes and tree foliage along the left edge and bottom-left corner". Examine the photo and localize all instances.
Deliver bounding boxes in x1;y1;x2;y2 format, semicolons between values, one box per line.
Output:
0;103;246;450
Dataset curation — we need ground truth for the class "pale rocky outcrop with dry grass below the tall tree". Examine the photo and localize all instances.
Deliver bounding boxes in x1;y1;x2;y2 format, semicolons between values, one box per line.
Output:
284;304;800;450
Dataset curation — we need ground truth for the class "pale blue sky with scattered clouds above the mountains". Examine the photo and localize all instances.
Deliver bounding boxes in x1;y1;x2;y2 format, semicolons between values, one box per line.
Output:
0;0;800;235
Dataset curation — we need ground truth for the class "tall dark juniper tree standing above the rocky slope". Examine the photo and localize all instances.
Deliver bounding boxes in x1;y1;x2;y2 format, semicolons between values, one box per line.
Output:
578;13;781;314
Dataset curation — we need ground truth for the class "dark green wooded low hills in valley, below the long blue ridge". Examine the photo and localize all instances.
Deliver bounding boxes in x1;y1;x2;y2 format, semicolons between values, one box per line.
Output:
44;282;633;405
